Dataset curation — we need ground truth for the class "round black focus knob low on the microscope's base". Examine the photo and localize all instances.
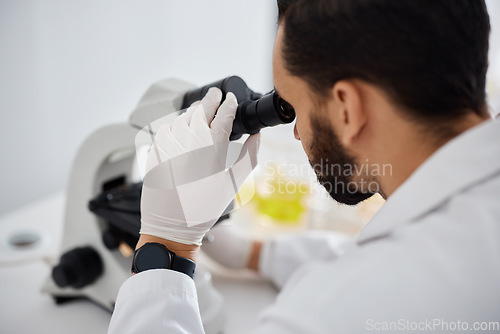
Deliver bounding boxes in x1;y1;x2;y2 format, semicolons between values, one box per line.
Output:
52;247;103;289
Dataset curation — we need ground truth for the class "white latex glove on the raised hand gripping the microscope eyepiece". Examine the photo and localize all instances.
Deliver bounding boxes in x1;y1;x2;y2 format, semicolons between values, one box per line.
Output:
140;88;260;245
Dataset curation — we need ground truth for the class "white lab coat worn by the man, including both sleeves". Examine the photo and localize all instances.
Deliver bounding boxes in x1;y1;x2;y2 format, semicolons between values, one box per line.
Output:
109;121;500;334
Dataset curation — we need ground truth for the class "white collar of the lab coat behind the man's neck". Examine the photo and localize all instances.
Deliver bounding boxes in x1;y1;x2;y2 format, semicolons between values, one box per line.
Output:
358;120;500;244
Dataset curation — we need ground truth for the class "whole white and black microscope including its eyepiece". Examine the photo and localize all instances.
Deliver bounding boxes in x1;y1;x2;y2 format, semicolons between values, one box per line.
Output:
42;76;295;334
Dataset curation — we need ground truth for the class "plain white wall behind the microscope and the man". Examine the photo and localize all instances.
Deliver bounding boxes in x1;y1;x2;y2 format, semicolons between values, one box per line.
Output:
0;0;500;214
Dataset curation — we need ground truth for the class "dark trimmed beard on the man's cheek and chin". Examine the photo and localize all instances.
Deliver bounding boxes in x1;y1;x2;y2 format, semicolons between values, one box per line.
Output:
309;116;374;205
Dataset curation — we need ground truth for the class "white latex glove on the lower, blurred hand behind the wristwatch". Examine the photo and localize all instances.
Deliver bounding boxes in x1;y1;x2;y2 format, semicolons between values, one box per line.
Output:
201;221;252;269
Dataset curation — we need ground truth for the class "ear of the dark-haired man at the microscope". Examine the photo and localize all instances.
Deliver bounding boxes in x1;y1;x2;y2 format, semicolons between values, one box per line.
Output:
332;80;368;147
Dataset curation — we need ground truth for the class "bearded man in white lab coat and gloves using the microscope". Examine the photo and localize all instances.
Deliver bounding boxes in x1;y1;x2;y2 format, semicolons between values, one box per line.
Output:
110;0;500;333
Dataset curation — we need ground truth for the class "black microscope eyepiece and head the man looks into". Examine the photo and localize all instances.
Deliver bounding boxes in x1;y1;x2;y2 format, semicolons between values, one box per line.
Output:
182;76;295;140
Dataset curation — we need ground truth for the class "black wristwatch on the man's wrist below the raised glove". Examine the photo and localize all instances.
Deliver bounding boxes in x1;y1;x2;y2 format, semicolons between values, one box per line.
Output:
132;242;196;278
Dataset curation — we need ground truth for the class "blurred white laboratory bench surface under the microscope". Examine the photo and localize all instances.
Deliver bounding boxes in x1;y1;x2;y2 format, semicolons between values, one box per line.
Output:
0;193;277;334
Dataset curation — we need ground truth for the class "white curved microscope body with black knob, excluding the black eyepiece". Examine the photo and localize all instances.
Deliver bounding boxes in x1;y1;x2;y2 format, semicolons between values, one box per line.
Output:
42;79;224;334
